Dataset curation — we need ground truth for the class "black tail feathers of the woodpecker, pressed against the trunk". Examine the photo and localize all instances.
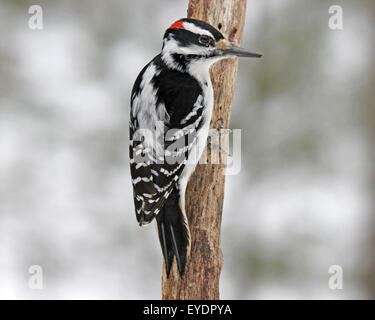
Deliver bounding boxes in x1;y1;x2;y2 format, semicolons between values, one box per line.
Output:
156;190;190;277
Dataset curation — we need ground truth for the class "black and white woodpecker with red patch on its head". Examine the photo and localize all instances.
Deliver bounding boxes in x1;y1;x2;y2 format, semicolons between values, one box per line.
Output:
129;18;261;276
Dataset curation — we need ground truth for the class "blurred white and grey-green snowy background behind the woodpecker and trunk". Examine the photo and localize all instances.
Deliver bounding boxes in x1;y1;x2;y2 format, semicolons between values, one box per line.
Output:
0;0;375;299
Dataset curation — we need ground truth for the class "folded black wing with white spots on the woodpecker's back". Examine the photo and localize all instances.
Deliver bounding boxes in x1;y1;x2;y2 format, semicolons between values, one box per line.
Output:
129;59;203;225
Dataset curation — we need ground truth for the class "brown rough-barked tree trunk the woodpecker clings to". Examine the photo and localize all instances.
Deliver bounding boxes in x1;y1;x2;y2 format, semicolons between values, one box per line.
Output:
162;0;246;300
